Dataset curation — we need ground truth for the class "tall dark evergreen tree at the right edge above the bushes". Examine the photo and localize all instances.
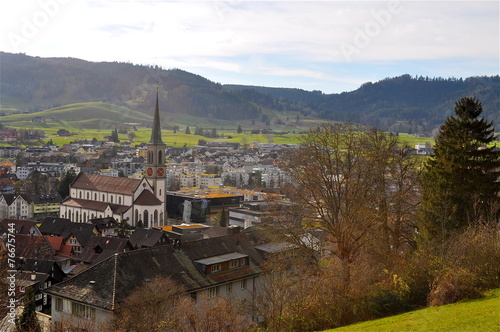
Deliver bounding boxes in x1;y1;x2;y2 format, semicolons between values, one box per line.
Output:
420;98;500;241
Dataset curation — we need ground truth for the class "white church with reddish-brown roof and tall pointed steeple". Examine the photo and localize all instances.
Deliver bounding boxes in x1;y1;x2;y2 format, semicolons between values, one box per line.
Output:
59;87;167;228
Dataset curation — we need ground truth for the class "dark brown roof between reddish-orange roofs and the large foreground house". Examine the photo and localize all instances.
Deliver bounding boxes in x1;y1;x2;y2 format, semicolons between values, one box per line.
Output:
80;236;134;263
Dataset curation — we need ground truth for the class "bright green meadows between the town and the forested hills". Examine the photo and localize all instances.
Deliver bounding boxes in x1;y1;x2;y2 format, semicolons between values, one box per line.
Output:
0;102;433;147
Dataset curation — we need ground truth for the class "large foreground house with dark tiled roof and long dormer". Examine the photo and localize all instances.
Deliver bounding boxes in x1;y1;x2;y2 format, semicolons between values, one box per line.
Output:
46;233;263;329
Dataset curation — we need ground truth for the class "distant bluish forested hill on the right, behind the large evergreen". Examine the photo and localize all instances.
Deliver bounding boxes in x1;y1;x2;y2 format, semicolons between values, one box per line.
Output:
226;75;500;133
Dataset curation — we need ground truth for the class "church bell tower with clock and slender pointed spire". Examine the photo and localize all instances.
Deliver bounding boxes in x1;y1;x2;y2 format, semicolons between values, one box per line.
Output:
145;85;166;208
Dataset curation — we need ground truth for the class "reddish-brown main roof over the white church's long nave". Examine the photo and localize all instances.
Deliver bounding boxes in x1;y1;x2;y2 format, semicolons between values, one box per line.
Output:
71;172;141;195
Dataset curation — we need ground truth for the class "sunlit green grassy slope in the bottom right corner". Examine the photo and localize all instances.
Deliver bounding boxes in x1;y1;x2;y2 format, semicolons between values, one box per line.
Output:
329;288;500;332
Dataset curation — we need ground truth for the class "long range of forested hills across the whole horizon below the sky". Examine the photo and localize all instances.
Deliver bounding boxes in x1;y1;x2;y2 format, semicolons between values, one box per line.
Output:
0;52;500;133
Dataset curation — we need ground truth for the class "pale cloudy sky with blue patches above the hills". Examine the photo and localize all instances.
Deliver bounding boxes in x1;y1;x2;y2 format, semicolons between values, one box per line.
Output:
0;0;500;93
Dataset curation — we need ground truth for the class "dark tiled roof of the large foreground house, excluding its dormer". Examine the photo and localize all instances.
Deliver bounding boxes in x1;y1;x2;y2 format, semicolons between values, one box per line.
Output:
46;234;262;310
